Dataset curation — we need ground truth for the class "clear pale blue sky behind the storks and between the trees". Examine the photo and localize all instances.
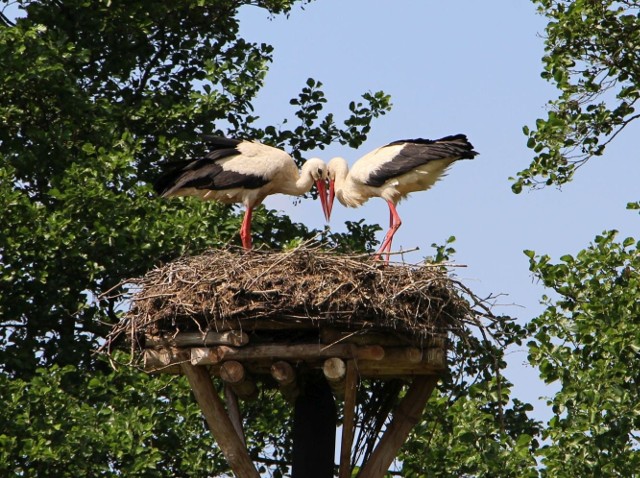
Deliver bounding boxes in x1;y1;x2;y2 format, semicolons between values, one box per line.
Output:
241;0;640;419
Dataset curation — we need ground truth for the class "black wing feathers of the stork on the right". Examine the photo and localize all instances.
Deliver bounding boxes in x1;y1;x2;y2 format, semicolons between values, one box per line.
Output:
366;134;478;187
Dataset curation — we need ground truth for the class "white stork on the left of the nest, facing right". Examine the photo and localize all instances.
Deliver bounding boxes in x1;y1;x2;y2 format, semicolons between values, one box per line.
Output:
154;135;329;250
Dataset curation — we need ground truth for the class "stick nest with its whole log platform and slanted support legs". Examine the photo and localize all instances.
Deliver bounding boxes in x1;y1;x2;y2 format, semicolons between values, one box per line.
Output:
103;247;488;478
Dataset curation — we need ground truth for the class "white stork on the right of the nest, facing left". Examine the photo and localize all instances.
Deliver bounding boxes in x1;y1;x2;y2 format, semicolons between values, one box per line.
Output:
327;134;478;262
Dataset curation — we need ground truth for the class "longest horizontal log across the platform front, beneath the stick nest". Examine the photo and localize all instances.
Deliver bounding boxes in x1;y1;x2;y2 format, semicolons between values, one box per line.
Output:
191;344;384;365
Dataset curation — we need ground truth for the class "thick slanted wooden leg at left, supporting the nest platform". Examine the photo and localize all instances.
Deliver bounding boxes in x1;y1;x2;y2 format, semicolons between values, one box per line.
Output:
180;363;260;478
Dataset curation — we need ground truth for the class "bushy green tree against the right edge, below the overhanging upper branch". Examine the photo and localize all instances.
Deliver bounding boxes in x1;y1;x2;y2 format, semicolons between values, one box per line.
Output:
527;227;640;476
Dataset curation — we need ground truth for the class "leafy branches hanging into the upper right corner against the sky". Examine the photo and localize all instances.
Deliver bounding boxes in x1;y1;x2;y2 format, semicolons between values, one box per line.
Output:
513;0;640;193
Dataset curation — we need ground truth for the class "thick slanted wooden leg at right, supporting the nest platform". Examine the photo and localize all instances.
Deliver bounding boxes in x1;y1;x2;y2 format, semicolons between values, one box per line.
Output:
359;376;438;478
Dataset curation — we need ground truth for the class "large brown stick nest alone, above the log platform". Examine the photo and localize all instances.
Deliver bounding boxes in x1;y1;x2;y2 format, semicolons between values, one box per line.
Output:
109;247;484;348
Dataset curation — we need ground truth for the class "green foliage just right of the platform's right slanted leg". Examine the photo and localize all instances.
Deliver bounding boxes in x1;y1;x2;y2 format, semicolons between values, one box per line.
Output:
399;317;541;477
